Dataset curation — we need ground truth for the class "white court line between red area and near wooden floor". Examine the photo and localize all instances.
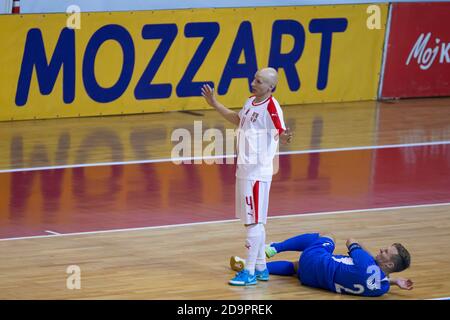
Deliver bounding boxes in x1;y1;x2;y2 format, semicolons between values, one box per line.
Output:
0;202;450;241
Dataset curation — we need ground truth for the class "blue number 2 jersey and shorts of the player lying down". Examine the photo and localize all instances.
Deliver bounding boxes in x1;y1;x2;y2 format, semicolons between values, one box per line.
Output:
298;238;390;296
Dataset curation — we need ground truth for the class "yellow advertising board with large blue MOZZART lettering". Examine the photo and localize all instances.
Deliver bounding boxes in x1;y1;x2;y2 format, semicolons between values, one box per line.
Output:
0;4;387;120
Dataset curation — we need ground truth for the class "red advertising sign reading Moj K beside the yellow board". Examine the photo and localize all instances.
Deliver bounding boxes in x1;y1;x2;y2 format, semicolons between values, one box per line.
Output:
381;2;450;98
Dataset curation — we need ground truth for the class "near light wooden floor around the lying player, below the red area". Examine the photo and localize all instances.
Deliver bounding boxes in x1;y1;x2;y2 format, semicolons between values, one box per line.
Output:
0;205;450;300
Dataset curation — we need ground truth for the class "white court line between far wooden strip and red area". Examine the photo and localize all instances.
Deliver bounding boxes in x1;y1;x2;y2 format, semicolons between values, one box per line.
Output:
0;141;450;173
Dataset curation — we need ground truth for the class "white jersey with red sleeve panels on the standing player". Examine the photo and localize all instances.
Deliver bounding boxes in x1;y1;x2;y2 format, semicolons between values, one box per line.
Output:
236;96;286;181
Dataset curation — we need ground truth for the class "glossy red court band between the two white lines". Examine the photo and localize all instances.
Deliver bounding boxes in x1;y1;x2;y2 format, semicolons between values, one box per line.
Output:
0;144;450;239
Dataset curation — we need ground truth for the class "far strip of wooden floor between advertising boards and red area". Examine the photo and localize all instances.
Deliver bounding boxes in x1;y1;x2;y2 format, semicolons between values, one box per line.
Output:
0;98;450;170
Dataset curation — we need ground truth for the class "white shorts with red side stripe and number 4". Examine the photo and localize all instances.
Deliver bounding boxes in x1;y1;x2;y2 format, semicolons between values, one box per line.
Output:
236;179;271;224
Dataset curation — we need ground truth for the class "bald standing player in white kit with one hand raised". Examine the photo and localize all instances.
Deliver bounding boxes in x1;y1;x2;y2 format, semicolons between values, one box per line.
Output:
202;68;292;286
